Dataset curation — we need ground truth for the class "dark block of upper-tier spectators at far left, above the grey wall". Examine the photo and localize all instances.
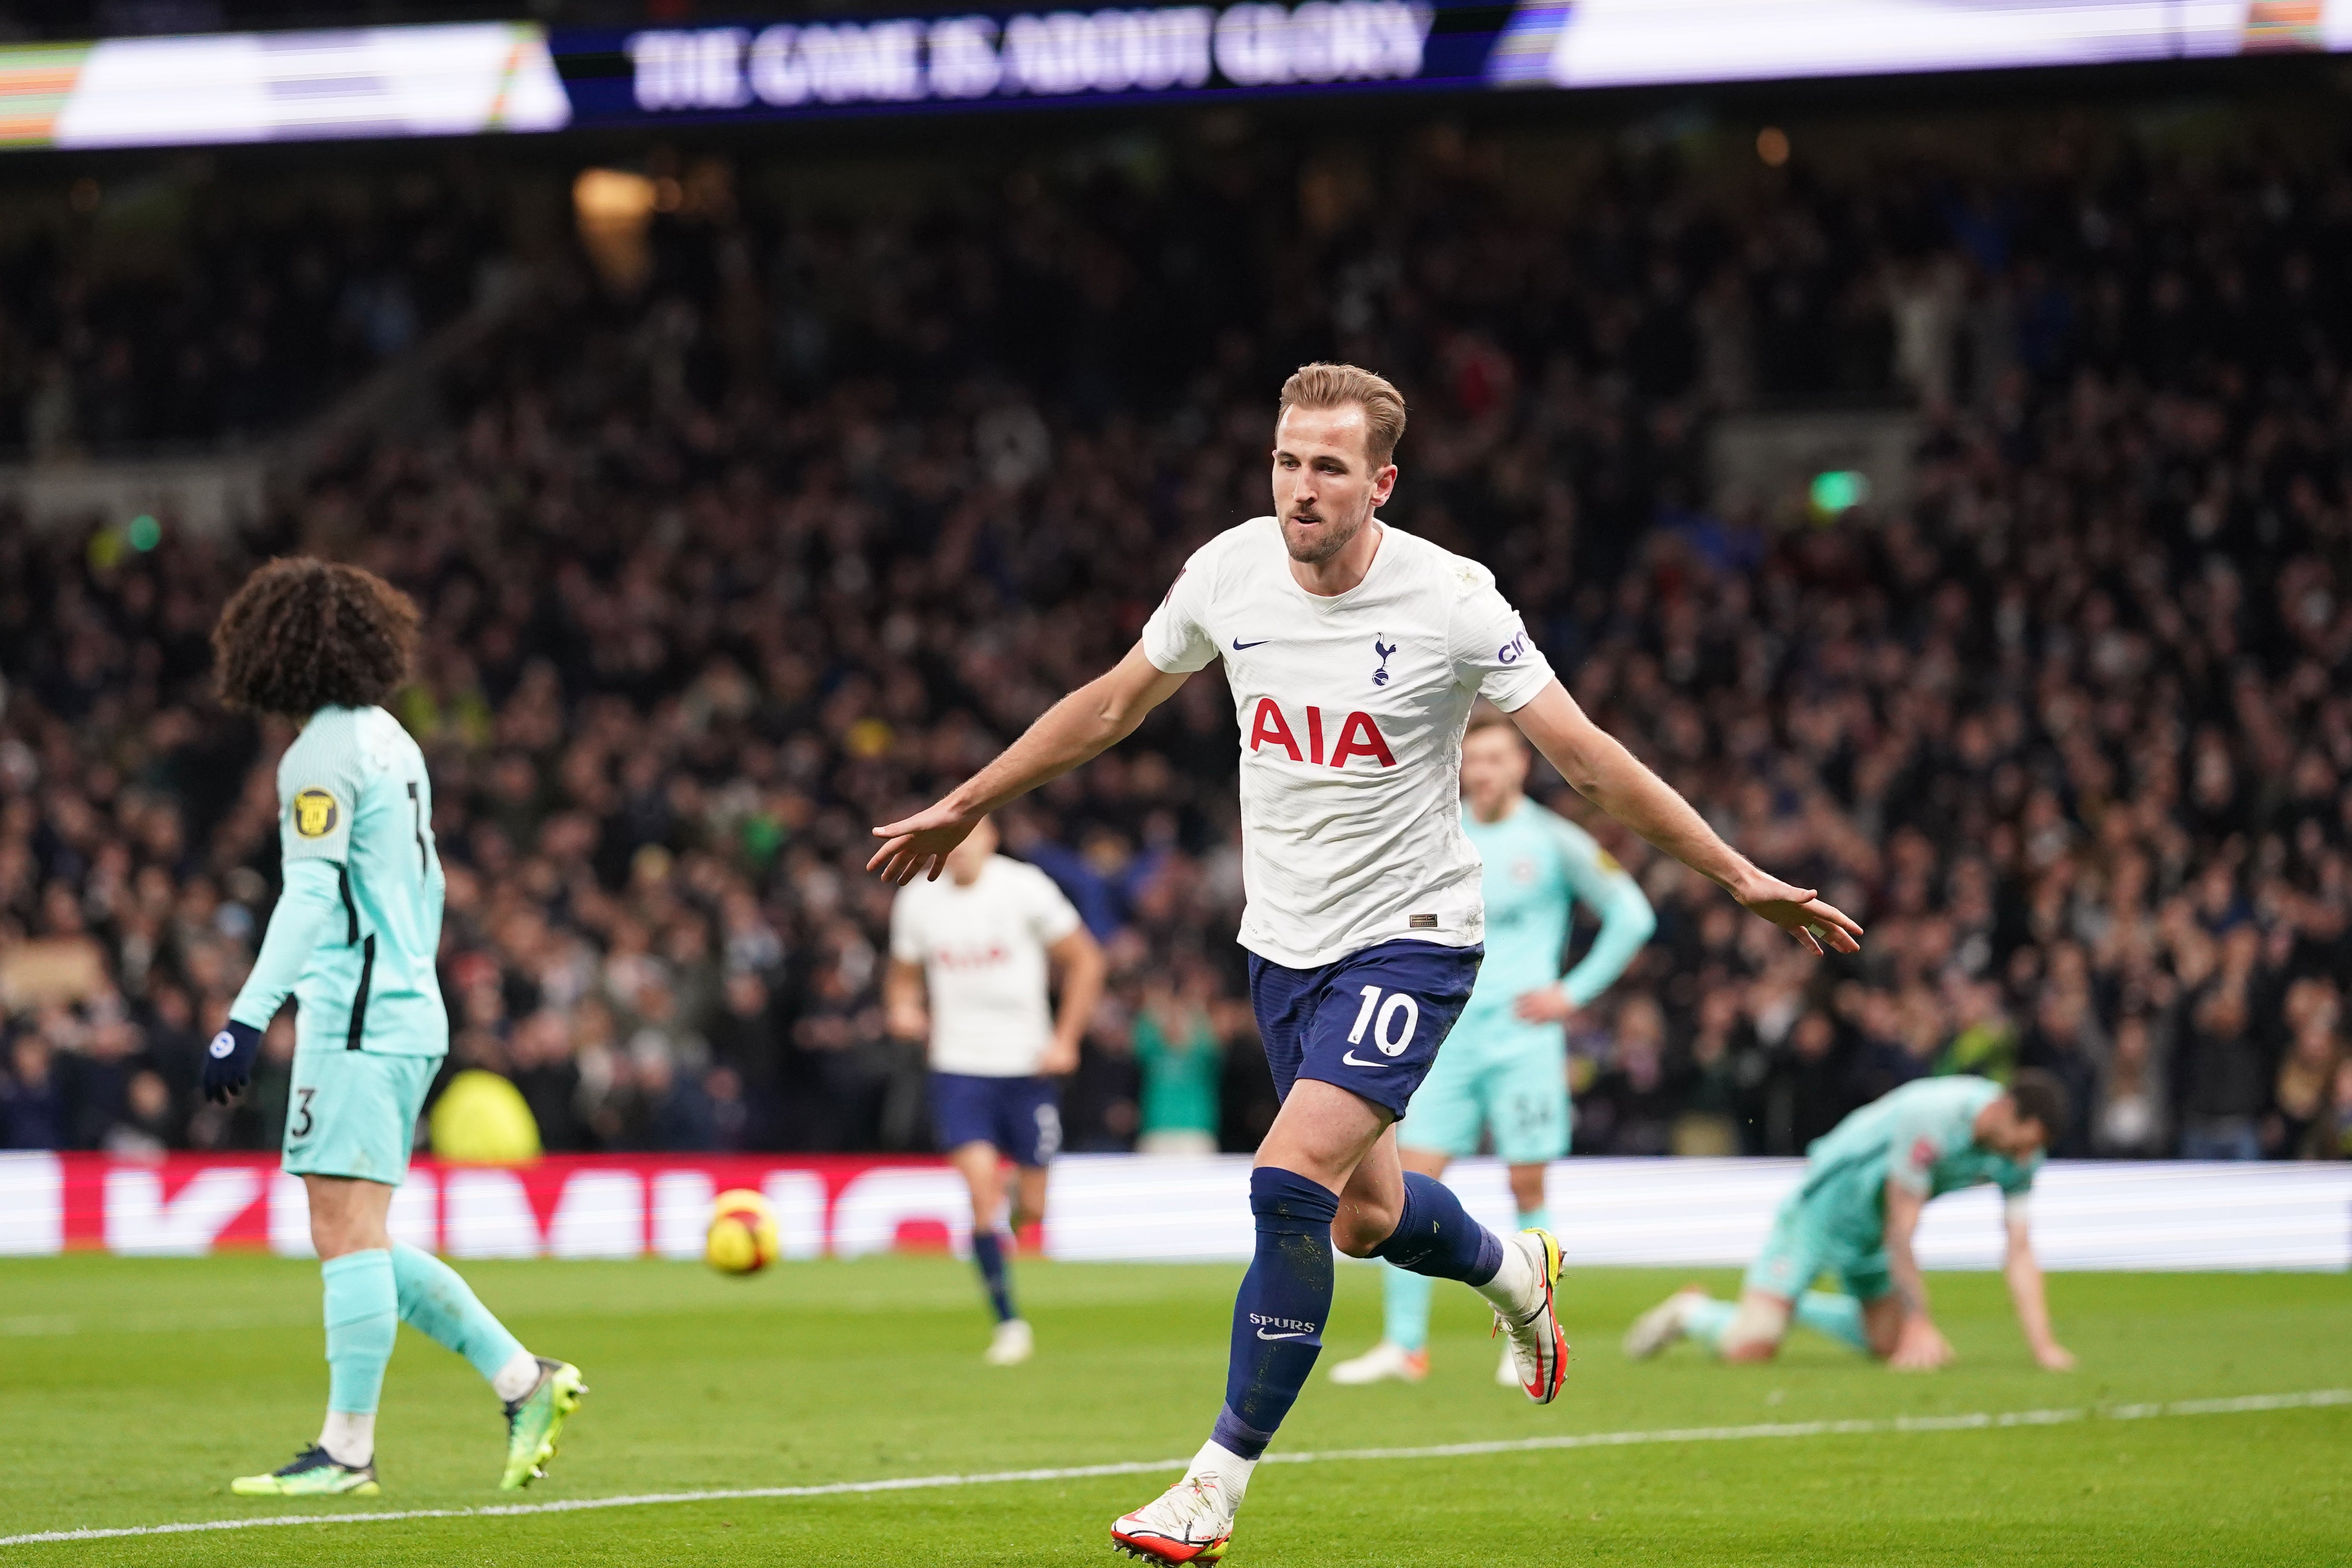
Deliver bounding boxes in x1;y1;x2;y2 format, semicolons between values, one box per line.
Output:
0;171;496;463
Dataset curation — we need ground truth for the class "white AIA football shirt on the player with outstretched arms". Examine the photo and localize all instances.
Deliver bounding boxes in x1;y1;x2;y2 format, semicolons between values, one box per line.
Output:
1143;517;1552;968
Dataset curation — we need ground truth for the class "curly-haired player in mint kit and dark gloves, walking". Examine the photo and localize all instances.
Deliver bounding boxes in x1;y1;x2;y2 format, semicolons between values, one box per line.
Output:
205;559;586;1498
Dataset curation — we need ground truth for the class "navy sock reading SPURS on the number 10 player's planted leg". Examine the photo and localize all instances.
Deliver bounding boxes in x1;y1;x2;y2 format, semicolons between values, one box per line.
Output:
1211;1166;1338;1460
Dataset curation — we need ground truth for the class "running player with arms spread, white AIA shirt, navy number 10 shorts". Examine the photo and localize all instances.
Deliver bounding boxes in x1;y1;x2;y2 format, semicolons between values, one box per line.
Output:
870;364;1861;1563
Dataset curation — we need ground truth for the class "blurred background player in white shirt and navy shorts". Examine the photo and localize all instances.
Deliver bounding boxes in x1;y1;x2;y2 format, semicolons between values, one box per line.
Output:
882;820;1106;1366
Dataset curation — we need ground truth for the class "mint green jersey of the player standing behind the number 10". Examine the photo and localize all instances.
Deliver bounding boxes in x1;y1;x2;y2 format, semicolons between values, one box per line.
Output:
1463;799;1658;1016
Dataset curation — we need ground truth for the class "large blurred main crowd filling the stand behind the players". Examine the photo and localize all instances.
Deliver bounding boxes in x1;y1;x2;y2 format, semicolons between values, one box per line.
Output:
0;107;2352;1159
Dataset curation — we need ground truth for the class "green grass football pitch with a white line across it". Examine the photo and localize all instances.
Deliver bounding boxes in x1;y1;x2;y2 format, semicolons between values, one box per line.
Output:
0;1255;2352;1568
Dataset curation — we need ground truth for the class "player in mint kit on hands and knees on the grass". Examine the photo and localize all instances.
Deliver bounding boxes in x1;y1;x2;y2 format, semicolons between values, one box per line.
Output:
1625;1067;2074;1373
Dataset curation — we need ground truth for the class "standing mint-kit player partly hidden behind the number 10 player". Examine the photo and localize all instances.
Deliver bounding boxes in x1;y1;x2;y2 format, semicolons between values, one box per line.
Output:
1331;703;1658;1387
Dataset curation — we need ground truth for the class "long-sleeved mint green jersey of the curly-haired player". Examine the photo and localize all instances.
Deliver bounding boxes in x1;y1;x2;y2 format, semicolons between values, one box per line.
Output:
228;707;449;1055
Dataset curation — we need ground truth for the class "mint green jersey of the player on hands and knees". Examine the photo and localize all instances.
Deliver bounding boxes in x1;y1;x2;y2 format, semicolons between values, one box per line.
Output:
1792;1077;2041;1246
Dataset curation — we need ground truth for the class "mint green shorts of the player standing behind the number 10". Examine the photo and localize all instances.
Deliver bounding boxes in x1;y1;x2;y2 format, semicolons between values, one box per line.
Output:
1397;1013;1569;1166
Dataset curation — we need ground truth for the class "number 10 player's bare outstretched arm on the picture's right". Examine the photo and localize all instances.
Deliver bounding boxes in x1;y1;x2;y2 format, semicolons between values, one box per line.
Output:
1510;679;1863;952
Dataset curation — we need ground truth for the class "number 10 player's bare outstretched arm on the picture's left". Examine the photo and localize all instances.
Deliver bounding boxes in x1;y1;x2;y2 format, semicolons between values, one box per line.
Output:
865;644;1185;886
